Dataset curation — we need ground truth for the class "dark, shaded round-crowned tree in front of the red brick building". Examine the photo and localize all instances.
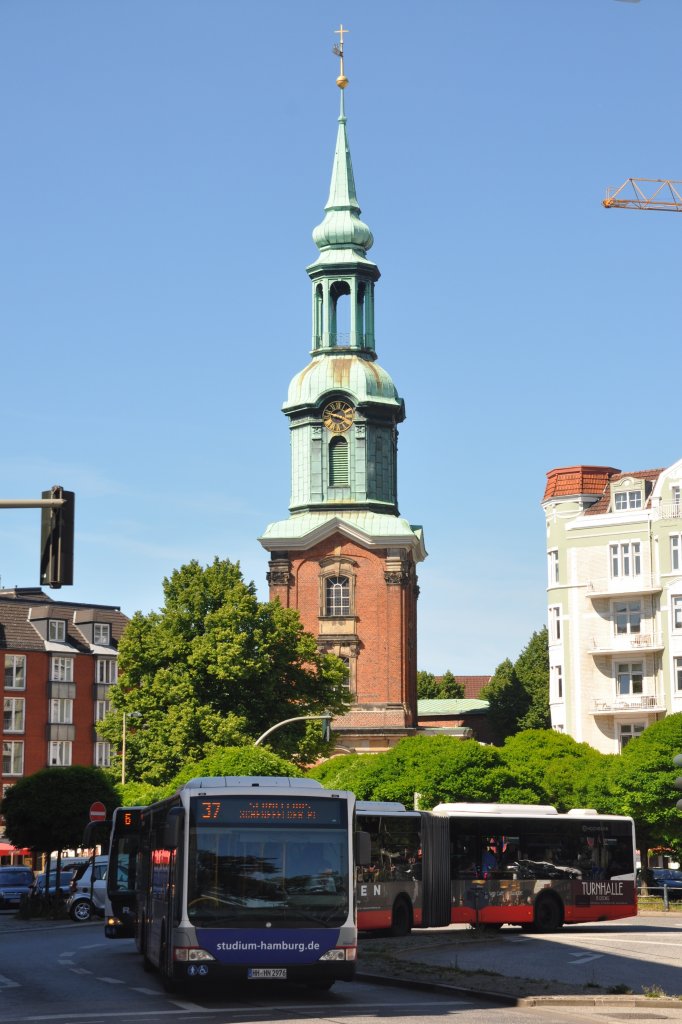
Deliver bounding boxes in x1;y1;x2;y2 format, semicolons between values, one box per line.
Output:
0;765;119;855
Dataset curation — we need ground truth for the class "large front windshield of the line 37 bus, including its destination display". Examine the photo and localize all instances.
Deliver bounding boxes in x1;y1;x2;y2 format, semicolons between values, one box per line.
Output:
187;796;349;928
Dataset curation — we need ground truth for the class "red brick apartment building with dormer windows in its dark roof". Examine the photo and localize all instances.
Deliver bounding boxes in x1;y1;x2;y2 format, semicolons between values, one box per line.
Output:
0;588;128;794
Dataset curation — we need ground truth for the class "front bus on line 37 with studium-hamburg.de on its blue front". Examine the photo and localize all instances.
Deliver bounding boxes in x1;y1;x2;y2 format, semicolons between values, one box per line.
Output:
112;776;364;989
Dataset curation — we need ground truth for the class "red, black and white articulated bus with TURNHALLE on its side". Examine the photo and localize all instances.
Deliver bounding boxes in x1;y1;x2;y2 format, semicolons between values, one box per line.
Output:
357;802;637;934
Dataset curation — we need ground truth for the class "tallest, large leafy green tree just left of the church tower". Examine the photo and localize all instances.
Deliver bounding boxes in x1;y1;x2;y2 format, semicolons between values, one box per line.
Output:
98;558;349;785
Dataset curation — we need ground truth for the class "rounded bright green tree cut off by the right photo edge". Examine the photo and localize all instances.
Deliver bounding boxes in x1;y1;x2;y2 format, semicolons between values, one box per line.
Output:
610;713;682;866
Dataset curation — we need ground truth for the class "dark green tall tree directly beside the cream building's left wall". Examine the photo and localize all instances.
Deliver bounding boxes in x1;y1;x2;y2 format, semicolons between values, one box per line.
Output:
480;627;550;743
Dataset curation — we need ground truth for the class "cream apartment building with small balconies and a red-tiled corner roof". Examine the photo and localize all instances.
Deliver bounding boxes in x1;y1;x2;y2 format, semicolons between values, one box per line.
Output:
543;460;682;754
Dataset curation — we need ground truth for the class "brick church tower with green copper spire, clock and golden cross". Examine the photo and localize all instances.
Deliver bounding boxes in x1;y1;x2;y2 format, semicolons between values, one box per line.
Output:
260;27;426;752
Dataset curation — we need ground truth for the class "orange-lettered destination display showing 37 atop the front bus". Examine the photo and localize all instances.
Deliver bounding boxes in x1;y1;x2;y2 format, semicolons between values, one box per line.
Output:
190;796;345;826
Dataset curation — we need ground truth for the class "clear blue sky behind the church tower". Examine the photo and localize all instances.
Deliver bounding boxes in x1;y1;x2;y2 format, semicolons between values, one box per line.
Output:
0;0;682;674
